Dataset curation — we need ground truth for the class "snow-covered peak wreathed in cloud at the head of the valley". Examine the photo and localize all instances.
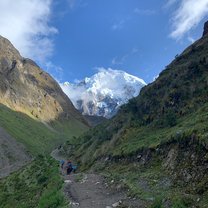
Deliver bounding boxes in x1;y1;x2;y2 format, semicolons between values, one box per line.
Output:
60;68;146;118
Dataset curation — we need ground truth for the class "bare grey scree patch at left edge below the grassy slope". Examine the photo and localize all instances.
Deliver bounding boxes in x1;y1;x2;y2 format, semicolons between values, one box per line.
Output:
0;127;32;178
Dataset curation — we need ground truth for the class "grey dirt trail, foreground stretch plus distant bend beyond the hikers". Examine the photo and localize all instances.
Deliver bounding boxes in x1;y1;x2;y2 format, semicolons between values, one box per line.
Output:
51;150;145;208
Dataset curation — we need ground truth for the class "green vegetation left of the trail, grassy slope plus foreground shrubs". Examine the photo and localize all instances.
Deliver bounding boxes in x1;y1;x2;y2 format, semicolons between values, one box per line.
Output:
0;105;86;208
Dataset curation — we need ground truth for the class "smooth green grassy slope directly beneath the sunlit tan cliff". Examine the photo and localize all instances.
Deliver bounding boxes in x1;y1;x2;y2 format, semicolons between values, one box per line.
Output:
0;105;86;155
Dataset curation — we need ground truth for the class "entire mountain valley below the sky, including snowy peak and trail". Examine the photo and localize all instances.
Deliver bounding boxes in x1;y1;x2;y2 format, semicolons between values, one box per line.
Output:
0;6;208;208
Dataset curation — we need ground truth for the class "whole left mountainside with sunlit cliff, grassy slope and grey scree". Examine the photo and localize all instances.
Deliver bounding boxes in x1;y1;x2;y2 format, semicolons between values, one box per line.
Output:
0;36;88;179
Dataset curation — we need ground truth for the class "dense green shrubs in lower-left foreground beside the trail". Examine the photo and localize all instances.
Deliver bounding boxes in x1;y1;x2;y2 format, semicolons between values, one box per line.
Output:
0;155;67;208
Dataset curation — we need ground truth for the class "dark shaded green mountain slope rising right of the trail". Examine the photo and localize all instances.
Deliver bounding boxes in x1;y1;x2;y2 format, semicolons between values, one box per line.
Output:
61;24;208;208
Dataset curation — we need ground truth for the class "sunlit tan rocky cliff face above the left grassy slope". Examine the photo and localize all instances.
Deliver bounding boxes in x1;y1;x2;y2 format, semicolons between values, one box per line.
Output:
0;36;85;122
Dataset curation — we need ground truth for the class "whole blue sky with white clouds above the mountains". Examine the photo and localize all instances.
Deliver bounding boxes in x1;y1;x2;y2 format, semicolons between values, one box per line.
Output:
0;0;208;83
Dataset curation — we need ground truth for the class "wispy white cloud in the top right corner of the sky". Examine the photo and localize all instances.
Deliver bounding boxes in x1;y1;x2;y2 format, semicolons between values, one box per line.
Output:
169;0;208;39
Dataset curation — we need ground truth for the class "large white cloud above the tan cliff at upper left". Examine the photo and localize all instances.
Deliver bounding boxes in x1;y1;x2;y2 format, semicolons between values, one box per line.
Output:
0;0;57;63
